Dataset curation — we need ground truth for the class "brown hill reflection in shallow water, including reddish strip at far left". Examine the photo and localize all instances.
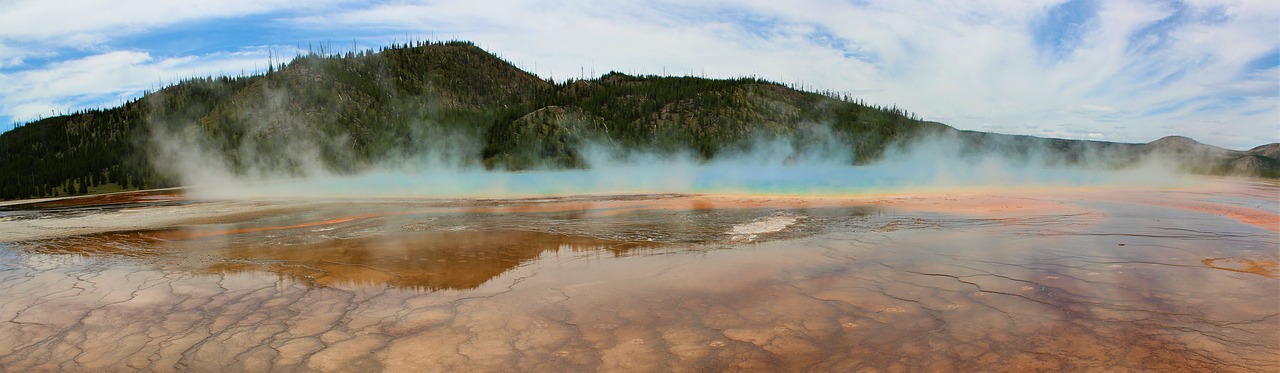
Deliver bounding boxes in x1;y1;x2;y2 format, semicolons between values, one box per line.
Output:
14;229;655;291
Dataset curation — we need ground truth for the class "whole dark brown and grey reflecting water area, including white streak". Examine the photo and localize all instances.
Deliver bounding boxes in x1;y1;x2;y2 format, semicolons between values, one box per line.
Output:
10;199;877;291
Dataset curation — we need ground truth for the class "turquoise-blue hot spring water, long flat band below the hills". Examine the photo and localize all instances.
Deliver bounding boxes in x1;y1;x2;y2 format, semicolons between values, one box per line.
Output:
200;163;1187;197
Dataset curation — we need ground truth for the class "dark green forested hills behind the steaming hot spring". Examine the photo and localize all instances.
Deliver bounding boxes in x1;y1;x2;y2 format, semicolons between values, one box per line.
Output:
0;41;1277;199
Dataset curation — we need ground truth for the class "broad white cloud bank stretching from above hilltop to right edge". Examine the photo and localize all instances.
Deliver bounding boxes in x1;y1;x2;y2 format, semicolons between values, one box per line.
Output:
280;1;1280;147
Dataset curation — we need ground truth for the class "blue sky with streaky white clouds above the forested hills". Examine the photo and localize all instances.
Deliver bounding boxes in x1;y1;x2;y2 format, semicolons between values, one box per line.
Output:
0;0;1280;150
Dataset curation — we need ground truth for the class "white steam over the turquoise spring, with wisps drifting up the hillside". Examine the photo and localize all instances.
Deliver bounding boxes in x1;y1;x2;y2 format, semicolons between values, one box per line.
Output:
151;80;1187;199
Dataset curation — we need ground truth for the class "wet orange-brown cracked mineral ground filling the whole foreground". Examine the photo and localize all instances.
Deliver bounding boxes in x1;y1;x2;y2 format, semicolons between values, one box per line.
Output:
0;179;1280;372
